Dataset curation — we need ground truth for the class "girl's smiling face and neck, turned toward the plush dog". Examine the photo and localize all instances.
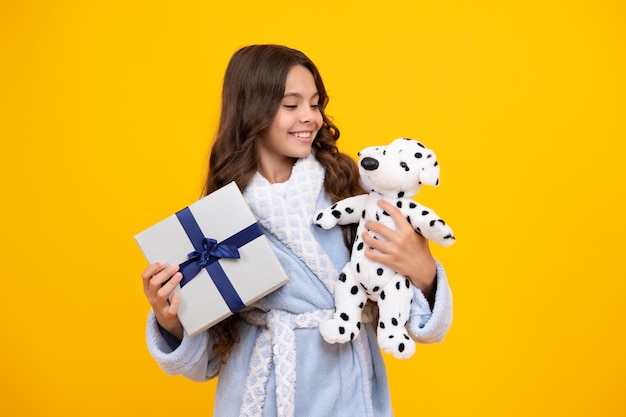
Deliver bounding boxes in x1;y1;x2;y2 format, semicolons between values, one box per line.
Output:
257;65;323;183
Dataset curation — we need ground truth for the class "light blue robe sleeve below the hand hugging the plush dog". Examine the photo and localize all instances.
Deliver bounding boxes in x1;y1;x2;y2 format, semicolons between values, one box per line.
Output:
407;261;452;344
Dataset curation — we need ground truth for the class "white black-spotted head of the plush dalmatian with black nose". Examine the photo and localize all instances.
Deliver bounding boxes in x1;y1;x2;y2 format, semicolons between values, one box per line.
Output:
359;138;439;198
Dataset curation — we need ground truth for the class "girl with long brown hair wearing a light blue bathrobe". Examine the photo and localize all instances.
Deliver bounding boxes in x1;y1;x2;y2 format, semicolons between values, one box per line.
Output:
142;45;452;417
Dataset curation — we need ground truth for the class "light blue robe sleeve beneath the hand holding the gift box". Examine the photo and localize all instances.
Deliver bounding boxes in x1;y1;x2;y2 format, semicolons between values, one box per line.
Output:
146;310;221;382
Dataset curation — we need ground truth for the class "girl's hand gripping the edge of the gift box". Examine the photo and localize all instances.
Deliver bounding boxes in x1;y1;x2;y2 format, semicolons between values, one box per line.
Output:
141;262;183;341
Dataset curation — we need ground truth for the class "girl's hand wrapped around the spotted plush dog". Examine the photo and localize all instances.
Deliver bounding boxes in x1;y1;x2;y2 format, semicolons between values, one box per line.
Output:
362;200;437;301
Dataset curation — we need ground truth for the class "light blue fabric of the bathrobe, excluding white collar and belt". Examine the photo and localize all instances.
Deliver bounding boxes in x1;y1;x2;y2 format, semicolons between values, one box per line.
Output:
147;160;452;417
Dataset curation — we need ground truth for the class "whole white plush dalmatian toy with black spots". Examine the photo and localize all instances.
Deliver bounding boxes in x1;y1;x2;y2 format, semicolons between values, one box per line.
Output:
313;138;455;359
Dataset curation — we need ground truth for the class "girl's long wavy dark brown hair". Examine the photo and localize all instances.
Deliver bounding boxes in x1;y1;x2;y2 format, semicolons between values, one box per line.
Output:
204;45;365;360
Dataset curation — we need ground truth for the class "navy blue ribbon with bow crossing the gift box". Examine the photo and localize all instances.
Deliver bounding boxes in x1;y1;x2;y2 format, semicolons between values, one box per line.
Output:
176;207;263;313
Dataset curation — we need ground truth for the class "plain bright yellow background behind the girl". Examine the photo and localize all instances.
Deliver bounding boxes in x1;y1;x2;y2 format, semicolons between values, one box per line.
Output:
0;0;626;416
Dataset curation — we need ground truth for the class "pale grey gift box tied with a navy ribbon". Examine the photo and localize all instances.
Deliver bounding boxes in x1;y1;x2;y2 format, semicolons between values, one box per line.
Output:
135;182;288;336
